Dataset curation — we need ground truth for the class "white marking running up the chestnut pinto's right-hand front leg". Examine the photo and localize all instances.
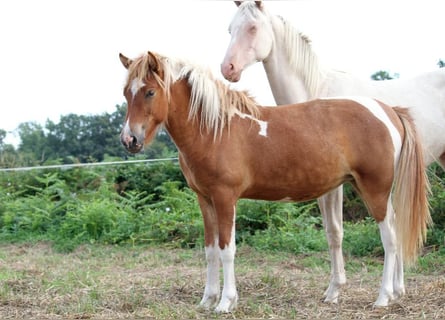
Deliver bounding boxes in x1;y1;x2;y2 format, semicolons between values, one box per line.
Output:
215;207;238;312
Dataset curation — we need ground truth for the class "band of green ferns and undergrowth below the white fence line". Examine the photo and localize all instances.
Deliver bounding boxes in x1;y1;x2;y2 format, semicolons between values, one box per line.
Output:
0;161;445;257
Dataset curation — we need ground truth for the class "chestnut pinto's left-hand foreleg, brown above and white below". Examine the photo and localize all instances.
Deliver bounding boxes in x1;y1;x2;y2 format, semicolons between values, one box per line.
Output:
198;195;220;309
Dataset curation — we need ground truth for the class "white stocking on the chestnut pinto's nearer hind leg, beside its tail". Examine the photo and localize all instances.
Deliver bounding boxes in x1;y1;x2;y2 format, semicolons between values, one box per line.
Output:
374;197;403;307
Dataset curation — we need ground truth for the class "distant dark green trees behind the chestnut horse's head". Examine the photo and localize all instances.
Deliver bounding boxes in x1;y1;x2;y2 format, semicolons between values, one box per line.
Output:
11;104;177;165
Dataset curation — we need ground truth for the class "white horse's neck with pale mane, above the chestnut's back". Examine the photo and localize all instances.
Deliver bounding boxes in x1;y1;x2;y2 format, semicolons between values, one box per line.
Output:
263;15;322;104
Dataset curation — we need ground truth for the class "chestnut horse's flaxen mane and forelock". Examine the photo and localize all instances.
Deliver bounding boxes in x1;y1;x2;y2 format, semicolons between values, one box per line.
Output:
126;54;258;137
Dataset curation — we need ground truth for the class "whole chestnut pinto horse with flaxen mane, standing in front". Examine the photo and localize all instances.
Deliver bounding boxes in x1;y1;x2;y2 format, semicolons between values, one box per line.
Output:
120;52;430;312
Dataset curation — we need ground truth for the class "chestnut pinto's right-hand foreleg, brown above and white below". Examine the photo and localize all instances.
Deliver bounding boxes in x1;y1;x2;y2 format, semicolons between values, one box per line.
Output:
215;205;238;312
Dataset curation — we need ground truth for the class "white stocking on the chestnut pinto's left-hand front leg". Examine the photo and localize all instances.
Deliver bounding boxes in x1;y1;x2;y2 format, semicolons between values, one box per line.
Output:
199;242;220;309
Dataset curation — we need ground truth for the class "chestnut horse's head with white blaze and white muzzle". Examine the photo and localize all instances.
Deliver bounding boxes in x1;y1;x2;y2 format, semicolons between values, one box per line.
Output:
119;52;169;153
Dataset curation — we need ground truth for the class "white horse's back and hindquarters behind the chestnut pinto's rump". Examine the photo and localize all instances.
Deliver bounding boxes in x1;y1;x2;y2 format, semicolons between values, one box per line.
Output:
320;68;445;165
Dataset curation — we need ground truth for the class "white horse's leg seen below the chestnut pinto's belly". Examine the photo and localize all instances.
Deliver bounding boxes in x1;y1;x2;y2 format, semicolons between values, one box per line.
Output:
318;186;346;303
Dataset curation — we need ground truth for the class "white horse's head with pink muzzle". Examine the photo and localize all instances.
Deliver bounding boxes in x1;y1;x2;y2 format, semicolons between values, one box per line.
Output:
221;1;274;82
